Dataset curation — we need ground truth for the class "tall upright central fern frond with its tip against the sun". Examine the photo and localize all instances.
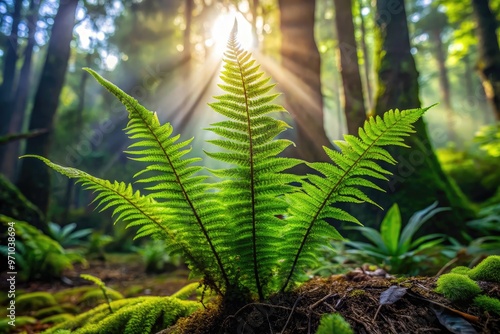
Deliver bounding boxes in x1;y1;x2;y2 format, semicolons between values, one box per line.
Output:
206;26;298;299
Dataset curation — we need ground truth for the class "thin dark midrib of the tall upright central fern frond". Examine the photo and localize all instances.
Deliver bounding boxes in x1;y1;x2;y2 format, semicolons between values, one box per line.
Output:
232;40;264;301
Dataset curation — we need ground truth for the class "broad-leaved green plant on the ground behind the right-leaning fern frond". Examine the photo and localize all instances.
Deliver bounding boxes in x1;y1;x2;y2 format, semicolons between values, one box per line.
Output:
347;202;448;274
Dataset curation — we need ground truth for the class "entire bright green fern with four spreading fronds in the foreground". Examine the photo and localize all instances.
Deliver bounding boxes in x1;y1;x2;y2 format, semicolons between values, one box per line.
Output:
25;27;425;306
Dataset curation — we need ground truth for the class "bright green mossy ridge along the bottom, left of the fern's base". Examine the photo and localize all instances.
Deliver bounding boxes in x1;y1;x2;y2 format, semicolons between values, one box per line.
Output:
44;297;201;334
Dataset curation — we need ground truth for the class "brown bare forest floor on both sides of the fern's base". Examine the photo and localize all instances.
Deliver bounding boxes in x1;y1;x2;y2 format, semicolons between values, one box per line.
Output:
7;255;500;334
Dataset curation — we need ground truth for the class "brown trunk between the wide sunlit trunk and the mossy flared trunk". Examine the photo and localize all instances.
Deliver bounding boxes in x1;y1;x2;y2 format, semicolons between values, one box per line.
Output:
334;0;366;135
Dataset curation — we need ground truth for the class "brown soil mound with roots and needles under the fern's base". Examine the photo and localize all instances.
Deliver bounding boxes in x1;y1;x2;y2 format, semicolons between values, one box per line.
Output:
169;274;500;334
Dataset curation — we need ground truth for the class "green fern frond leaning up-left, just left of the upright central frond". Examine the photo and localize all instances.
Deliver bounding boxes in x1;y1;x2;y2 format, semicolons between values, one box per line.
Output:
86;69;229;286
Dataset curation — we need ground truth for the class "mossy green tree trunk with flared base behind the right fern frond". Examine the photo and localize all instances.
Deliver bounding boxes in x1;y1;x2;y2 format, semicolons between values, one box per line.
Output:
375;0;472;236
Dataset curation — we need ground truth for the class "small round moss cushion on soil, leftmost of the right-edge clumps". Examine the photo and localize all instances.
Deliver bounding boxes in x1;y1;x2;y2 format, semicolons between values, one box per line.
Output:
436;273;481;302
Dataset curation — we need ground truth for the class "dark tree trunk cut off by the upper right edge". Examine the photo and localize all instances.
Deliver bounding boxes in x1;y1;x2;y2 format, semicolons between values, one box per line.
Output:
472;0;500;121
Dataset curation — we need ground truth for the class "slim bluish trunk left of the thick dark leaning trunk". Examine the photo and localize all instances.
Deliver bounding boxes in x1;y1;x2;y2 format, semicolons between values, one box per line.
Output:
0;0;40;181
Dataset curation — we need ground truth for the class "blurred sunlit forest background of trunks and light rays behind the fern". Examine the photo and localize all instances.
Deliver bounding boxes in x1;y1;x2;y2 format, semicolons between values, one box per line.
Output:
0;0;500;245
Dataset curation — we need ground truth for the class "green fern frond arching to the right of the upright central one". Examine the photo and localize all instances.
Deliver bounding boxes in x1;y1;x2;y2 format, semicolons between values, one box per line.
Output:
282;108;428;290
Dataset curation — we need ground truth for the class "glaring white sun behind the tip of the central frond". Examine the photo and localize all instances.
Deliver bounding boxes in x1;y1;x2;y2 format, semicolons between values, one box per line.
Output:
207;10;253;52
